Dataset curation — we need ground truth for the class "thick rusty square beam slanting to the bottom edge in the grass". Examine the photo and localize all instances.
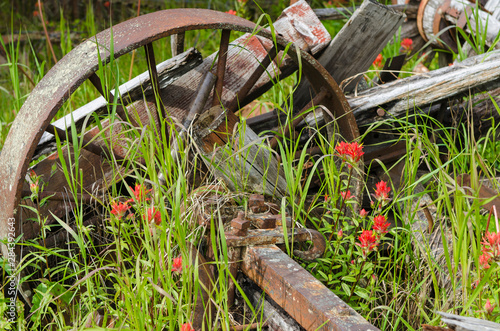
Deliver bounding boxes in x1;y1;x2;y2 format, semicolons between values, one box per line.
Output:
241;245;378;331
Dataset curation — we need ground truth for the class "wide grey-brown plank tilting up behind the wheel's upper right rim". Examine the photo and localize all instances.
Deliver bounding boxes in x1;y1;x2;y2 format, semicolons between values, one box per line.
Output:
294;0;406;109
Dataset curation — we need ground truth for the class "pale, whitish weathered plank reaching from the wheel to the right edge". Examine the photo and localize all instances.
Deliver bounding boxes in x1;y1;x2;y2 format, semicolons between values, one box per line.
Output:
348;51;500;125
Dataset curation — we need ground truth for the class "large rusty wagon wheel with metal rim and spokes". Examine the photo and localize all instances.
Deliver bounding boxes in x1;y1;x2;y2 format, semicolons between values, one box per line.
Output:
0;9;359;272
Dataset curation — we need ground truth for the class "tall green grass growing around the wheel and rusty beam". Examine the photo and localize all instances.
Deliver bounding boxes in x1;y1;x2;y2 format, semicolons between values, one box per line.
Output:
0;4;500;330
